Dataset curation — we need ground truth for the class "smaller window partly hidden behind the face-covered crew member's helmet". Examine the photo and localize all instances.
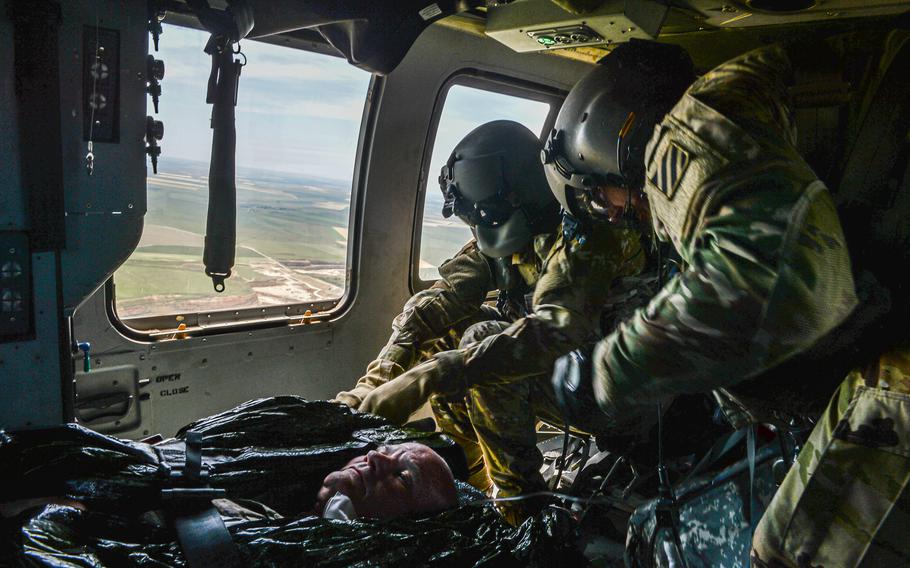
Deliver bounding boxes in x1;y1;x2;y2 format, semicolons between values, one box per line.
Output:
417;84;555;281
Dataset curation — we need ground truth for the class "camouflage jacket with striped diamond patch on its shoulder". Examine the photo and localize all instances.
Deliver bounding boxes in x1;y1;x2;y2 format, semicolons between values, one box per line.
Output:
594;46;857;426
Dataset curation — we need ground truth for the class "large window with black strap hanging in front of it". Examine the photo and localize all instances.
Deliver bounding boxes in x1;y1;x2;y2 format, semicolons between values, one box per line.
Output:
114;26;371;329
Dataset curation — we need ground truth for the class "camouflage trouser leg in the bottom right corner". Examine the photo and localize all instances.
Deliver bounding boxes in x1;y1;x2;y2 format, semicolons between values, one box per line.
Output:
752;341;910;568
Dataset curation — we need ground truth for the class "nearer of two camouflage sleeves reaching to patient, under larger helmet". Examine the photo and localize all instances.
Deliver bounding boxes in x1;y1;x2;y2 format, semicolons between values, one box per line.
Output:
360;221;646;421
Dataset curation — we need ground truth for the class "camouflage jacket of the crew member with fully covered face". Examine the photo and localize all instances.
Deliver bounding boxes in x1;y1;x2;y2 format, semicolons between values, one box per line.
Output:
335;240;545;408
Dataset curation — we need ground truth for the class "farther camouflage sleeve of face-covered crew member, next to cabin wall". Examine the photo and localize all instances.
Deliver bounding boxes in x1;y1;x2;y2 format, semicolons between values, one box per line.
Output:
335;241;495;408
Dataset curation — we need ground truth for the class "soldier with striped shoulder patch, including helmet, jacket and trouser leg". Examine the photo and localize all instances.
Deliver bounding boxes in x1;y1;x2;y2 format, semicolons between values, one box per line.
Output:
546;42;876;566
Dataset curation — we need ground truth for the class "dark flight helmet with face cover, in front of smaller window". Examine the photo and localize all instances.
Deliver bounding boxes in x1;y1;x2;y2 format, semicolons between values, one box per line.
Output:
439;120;559;258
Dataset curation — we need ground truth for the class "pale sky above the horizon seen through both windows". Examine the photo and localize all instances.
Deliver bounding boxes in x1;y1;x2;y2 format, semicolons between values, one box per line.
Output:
149;25;550;280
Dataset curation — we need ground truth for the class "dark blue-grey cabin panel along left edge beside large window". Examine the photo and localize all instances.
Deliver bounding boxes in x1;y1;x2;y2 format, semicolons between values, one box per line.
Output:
0;0;148;427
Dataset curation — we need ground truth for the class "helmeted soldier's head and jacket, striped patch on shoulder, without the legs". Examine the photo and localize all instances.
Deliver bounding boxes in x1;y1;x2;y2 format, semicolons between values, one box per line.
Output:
546;41;857;432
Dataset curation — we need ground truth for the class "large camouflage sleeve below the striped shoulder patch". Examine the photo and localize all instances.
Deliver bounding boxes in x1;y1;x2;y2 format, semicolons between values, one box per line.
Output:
594;178;856;418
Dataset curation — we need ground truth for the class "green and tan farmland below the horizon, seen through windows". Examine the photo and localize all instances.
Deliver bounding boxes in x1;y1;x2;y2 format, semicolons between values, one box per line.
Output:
114;158;469;318
